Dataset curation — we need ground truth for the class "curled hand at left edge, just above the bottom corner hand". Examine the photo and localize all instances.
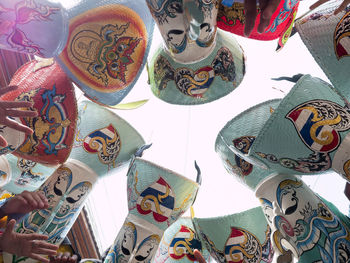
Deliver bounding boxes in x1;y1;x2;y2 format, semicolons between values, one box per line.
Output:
1;191;49;216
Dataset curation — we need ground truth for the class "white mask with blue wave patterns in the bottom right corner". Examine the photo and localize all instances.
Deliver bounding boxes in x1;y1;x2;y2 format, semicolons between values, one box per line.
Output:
255;174;350;262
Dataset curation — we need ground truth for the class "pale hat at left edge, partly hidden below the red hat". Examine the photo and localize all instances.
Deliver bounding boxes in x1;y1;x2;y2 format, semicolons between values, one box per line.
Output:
0;154;57;194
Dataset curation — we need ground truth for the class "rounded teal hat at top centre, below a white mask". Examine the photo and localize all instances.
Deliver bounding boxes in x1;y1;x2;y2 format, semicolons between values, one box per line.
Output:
148;30;245;105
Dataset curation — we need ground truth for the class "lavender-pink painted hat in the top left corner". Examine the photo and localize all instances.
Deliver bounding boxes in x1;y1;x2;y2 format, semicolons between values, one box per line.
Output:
0;0;68;58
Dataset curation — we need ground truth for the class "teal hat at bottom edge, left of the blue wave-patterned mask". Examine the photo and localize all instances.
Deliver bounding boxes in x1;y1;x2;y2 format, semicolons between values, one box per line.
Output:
193;207;274;263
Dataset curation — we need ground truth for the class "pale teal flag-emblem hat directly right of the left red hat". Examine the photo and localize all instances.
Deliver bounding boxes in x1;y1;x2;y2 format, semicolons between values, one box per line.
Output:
69;101;145;176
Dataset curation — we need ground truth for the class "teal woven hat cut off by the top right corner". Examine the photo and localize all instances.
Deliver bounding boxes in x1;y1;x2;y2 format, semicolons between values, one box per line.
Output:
295;1;350;99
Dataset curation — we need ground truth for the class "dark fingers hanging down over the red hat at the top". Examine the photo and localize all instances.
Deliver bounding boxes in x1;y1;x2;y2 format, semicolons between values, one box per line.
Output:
244;0;281;37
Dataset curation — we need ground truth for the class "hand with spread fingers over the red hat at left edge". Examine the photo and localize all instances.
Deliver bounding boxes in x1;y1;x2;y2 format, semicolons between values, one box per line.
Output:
0;86;38;147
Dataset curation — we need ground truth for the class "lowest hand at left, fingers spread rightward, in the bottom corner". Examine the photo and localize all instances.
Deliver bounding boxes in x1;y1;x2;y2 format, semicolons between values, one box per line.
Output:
0;219;58;263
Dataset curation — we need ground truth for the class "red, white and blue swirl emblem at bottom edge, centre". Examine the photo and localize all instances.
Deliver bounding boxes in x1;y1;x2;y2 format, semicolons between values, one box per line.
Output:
168;225;202;261
